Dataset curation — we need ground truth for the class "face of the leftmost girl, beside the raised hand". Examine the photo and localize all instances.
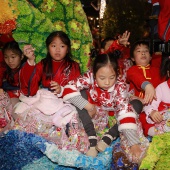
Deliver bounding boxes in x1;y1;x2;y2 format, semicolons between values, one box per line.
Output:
4;50;23;69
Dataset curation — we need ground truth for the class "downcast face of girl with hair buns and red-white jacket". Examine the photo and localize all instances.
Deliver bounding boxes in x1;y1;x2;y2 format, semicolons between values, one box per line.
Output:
95;65;116;90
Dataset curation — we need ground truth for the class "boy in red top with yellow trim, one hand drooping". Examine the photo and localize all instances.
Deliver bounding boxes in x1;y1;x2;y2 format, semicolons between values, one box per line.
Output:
127;41;163;134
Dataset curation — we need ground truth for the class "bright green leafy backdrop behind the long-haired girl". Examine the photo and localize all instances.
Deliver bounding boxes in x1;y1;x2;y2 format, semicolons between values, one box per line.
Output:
13;0;93;73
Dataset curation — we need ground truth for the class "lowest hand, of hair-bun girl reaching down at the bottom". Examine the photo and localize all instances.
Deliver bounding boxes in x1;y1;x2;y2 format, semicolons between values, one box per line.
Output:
130;144;142;163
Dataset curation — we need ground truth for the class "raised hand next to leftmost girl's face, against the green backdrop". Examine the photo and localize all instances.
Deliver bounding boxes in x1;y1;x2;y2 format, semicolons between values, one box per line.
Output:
23;45;35;64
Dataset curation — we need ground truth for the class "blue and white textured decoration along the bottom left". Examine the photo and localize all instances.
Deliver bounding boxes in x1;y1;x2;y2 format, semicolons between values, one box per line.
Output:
0;130;119;170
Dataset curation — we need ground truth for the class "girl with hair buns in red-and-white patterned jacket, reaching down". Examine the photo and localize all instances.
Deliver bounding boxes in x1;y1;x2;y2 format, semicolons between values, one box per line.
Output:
63;51;147;161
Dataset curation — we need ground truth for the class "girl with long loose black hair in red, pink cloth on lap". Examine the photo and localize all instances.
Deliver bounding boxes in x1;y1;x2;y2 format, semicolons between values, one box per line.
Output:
24;31;80;95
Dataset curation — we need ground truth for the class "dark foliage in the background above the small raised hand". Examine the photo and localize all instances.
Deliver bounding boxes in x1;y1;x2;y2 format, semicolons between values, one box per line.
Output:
102;0;149;42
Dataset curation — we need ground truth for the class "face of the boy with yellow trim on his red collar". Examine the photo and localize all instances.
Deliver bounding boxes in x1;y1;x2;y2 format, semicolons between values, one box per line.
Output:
132;44;151;66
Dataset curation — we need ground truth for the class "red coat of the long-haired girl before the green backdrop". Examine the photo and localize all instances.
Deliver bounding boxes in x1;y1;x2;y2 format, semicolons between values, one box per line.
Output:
28;60;80;95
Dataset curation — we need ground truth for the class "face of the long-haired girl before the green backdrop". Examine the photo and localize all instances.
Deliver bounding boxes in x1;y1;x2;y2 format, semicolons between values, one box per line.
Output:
48;37;68;61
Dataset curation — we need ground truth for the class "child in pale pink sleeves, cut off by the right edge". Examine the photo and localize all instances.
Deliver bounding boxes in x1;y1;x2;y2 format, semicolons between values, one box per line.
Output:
144;53;170;136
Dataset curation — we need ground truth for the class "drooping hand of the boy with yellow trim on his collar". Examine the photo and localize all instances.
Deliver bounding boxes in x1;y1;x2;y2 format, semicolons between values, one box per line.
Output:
143;84;157;104
